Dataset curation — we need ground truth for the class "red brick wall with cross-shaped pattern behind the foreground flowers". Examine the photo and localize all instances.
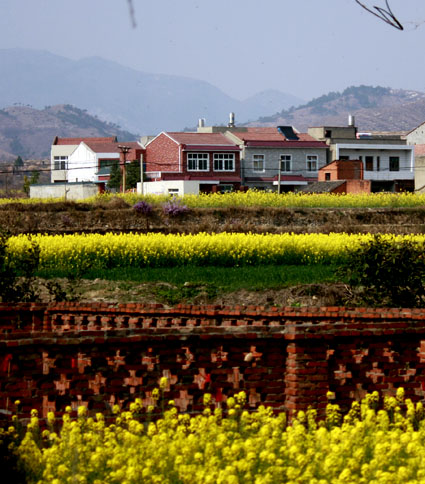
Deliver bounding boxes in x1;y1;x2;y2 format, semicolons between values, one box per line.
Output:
0;303;425;416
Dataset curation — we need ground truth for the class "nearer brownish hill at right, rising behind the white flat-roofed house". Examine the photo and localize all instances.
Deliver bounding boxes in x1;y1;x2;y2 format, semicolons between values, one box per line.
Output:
252;86;425;131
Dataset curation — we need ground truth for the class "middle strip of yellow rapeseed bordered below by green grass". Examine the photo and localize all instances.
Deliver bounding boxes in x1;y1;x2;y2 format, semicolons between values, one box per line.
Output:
8;233;425;270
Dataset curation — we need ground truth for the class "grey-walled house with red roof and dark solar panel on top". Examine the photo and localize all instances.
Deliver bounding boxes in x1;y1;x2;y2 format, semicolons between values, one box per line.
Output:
226;126;327;191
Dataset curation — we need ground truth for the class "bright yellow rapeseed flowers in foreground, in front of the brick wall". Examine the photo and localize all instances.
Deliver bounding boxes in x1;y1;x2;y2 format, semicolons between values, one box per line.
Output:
6;389;425;484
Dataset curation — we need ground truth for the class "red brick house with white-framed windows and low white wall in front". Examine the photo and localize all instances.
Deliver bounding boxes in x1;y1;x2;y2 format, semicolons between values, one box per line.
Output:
143;132;241;195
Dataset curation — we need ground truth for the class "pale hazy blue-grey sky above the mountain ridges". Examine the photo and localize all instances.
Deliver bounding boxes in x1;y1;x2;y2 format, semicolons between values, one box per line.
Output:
0;0;425;100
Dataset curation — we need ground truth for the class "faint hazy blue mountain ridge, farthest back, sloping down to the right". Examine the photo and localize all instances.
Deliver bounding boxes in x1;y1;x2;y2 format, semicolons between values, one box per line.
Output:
0;49;305;135
